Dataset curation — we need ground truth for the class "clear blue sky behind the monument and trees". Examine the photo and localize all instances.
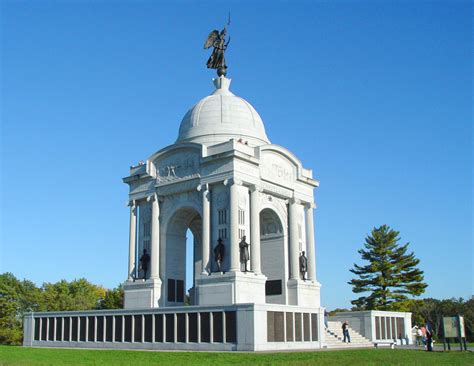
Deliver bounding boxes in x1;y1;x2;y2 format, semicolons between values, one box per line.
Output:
0;1;474;308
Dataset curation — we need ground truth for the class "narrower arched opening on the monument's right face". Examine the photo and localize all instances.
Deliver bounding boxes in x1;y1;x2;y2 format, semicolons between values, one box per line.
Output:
260;208;286;304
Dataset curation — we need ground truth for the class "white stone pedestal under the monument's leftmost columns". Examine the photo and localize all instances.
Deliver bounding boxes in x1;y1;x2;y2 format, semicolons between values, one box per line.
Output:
123;278;161;309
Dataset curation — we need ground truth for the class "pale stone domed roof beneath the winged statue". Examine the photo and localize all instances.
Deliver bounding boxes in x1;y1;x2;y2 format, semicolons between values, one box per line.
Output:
176;76;270;146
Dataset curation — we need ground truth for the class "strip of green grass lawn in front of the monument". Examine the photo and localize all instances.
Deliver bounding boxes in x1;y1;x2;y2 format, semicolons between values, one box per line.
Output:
0;346;474;366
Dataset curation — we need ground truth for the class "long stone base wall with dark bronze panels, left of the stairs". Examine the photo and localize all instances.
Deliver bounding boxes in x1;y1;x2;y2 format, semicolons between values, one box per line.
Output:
23;304;324;351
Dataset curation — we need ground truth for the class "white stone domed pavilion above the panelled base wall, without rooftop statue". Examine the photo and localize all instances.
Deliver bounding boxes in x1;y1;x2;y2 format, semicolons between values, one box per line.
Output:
123;76;320;309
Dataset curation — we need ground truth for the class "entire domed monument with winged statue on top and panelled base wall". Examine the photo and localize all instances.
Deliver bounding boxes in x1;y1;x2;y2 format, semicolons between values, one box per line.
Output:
25;22;336;350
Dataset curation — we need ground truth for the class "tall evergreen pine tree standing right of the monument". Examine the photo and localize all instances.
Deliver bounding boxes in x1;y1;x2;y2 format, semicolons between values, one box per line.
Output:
348;225;428;310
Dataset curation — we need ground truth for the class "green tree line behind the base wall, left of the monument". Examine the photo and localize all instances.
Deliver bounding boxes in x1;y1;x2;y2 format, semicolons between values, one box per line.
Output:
0;273;123;345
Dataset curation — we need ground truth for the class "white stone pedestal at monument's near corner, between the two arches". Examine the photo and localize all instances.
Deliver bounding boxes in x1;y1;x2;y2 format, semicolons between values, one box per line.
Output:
196;272;267;305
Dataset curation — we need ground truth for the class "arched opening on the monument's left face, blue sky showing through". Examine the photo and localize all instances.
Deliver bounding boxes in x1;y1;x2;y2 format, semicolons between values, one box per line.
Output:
164;208;202;306
